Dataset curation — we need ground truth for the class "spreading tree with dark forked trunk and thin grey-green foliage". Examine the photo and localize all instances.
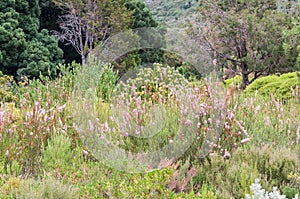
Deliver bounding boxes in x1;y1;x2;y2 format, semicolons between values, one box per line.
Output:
191;0;291;89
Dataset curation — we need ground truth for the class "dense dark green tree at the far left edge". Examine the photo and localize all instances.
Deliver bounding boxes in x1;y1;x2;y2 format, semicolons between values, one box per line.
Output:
0;0;63;77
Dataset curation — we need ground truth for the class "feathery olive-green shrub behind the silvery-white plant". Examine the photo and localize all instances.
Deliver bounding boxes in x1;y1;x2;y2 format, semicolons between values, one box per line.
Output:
193;146;297;198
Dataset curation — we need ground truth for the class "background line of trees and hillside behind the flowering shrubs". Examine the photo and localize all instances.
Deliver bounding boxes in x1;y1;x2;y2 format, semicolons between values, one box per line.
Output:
0;0;300;89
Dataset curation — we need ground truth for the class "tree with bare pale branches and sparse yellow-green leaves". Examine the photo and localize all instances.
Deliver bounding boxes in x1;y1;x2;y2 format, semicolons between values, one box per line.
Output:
53;0;132;65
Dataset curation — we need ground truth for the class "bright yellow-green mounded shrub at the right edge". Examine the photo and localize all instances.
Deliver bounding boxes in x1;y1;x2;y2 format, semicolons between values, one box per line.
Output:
245;72;300;99
